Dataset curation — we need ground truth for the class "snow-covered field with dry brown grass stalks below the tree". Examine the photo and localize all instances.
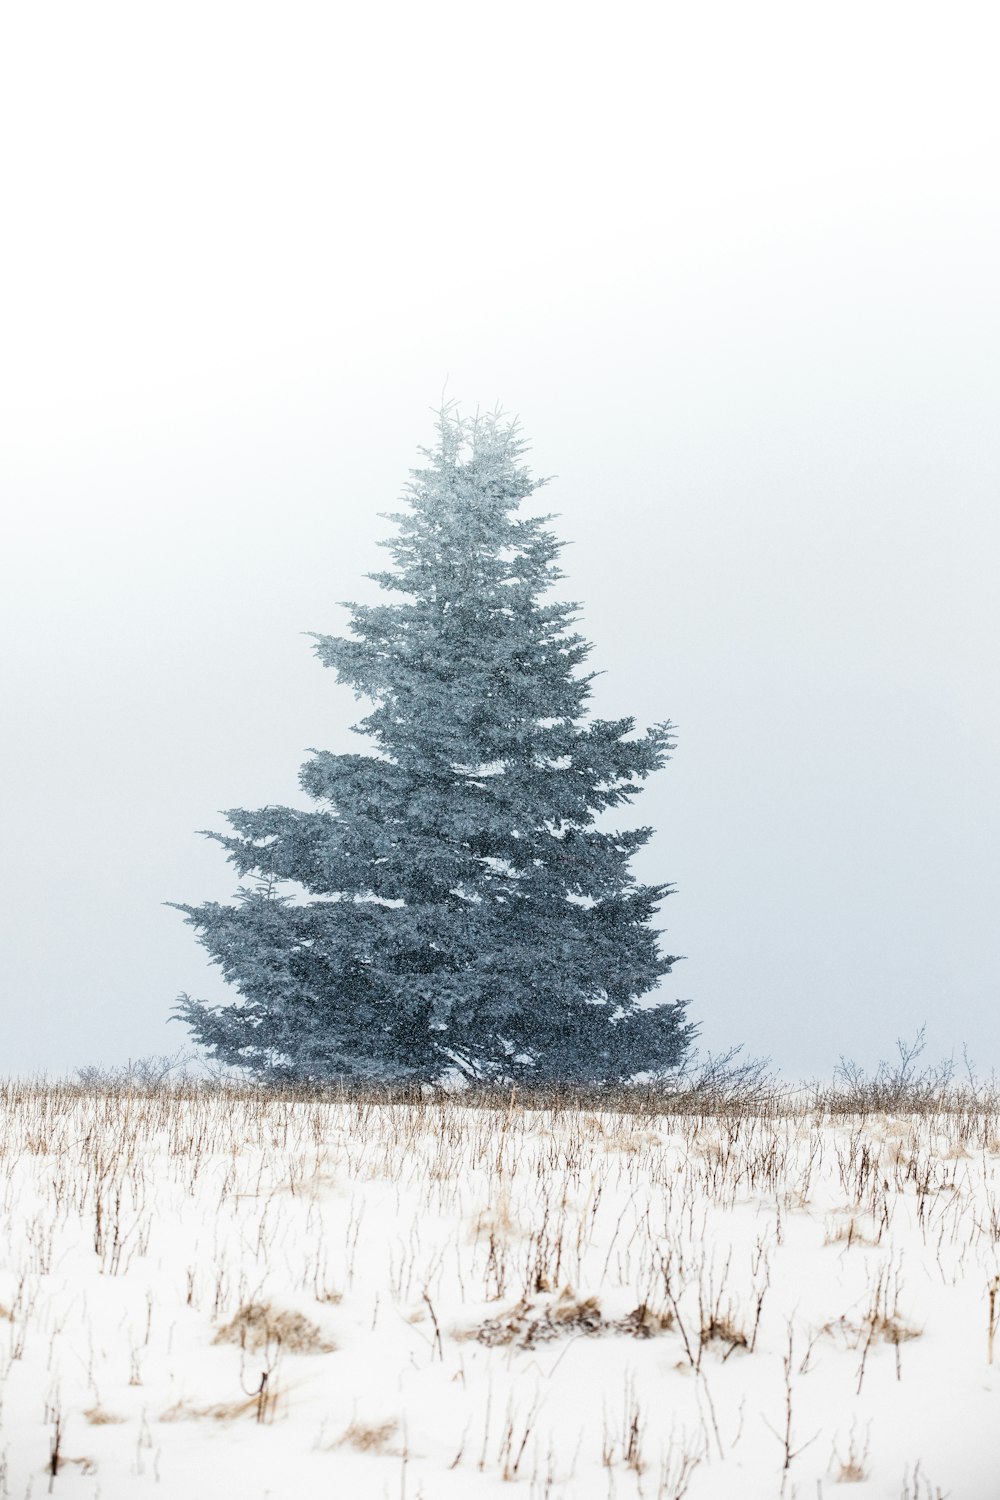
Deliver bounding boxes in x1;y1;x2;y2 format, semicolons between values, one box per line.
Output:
0;1085;1000;1500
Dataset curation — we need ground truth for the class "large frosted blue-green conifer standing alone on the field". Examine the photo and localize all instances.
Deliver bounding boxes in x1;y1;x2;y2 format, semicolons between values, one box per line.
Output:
174;407;694;1082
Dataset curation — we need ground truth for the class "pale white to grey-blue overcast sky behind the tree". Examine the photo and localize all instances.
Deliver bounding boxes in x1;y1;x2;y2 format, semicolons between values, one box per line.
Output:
0;0;1000;1076
